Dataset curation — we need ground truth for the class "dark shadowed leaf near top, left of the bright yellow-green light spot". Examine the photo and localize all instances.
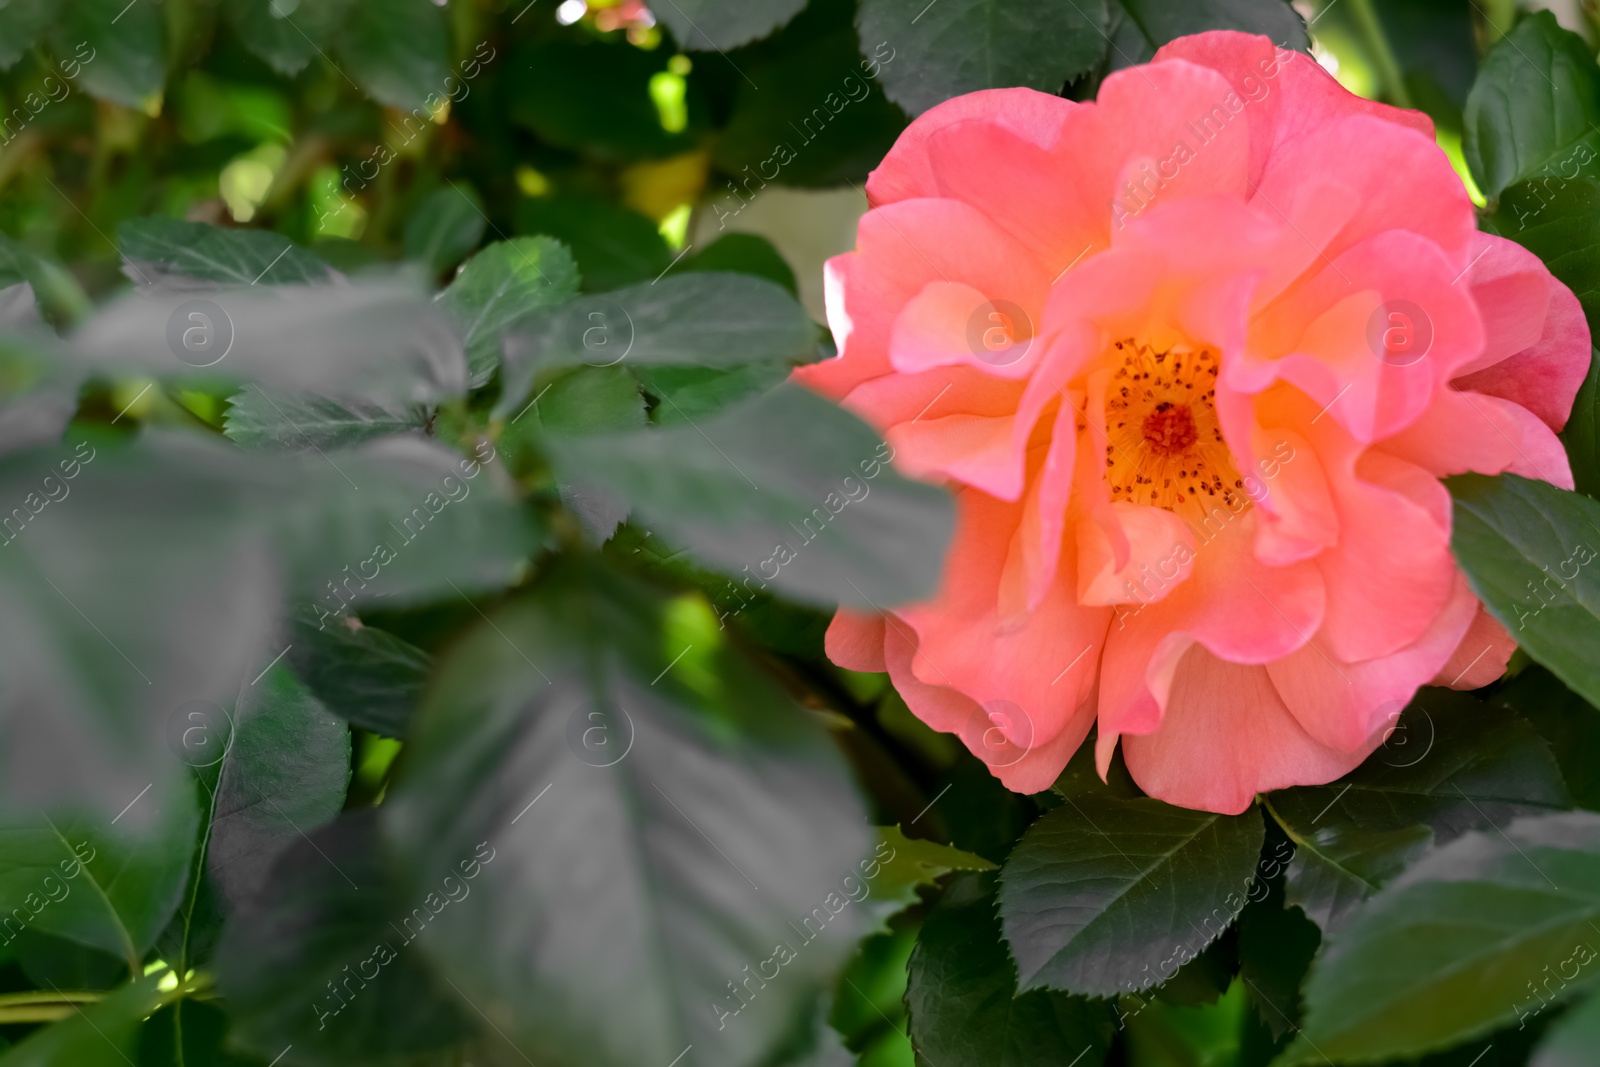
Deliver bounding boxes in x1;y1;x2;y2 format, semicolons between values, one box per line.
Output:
507;40;704;160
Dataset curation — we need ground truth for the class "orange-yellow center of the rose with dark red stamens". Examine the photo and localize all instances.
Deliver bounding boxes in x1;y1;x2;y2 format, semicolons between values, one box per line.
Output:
1102;339;1250;520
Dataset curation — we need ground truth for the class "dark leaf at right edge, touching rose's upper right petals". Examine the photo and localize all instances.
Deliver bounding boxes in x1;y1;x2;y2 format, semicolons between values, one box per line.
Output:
1483;174;1600;331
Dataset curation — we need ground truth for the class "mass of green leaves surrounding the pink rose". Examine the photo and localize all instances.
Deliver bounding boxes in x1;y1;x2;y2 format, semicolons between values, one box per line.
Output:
0;0;1600;1067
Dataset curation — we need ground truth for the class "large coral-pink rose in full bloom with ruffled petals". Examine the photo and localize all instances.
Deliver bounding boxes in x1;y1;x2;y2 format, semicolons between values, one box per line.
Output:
797;32;1589;813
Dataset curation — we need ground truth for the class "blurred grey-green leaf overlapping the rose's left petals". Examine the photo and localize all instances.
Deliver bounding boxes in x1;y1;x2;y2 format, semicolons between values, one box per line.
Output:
547;386;954;608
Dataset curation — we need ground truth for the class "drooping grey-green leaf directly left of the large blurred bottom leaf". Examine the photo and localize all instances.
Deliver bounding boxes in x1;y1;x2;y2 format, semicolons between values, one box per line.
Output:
206;665;350;907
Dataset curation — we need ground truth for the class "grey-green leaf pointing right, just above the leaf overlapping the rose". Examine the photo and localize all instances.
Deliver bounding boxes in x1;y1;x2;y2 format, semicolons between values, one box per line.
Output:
498;274;816;414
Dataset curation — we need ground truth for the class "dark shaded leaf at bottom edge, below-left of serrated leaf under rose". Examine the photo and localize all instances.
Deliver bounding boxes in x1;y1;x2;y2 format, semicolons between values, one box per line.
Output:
906;875;1112;1067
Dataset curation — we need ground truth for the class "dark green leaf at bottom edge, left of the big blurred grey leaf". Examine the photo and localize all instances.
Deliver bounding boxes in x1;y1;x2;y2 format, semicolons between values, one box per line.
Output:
218;813;470;1067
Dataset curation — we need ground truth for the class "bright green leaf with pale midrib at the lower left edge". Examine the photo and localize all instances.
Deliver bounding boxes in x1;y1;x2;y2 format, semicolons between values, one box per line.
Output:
0;789;198;973
